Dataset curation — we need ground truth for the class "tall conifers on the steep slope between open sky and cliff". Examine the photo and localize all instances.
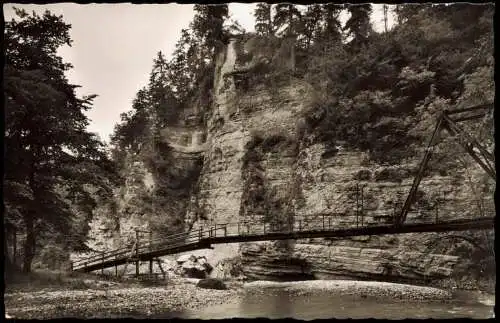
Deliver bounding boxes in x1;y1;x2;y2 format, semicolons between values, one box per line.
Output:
112;5;231;154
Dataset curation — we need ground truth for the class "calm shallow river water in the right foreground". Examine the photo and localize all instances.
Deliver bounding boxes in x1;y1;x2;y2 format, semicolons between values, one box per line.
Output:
169;287;494;320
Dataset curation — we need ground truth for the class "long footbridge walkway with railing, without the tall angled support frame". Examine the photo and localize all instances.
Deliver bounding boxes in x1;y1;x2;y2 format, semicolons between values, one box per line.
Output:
73;216;495;272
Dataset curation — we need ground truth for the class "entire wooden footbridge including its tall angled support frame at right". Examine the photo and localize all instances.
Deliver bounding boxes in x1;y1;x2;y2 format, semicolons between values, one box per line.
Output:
72;104;496;272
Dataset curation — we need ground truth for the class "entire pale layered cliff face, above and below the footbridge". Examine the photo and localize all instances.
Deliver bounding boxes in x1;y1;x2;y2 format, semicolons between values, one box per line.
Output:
81;40;493;286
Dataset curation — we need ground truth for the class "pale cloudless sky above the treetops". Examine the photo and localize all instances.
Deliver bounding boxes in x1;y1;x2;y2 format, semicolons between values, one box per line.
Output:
4;3;392;142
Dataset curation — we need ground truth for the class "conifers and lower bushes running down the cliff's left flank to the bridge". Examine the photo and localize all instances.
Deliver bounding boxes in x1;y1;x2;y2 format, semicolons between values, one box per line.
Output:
107;5;232;234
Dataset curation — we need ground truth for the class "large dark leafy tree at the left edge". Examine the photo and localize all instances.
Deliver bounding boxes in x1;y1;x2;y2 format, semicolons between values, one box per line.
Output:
4;9;117;271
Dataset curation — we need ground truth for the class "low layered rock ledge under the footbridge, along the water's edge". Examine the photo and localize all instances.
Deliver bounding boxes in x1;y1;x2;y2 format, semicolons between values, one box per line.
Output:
242;243;458;281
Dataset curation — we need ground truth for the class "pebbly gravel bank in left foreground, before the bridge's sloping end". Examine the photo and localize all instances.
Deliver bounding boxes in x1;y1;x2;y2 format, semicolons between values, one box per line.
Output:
4;280;238;319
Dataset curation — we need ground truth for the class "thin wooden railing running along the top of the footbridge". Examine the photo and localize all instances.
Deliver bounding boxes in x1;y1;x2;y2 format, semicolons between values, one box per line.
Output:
73;211;496;270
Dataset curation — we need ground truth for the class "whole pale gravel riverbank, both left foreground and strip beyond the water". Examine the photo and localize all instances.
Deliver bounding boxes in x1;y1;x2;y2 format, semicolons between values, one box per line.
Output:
4;278;494;319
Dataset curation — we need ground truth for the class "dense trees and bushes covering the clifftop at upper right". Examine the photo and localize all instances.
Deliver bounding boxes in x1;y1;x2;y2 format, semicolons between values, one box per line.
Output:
248;4;494;167
